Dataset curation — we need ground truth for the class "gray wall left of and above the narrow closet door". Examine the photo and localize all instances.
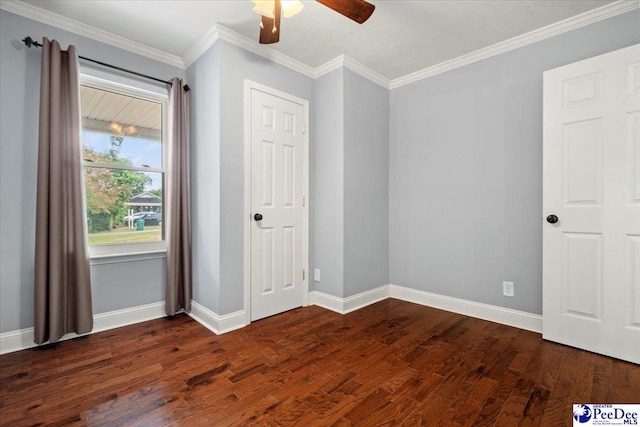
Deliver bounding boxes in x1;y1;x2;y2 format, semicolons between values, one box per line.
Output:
187;41;314;315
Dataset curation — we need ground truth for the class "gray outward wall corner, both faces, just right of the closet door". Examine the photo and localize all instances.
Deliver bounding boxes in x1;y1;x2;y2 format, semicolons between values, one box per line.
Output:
311;69;389;297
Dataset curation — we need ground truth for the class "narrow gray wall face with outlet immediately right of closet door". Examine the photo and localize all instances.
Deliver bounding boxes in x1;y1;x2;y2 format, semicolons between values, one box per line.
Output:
309;69;344;297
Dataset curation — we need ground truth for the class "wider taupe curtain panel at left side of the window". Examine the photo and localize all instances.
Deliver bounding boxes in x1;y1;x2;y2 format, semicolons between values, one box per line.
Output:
34;38;93;344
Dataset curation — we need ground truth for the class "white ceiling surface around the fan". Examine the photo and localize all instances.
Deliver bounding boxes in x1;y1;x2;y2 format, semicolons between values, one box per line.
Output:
16;0;624;80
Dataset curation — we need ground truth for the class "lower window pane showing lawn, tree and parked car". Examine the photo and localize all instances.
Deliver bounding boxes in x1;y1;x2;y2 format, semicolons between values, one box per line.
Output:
84;166;164;245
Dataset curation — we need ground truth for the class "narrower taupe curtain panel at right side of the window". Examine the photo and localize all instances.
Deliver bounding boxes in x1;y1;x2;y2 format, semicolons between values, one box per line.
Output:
165;78;191;316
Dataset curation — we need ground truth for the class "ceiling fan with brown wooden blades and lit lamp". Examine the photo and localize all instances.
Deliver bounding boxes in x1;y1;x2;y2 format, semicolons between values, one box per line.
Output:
251;0;376;44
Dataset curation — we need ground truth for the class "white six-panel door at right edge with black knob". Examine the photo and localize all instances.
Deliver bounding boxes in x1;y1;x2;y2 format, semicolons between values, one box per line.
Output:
543;45;640;363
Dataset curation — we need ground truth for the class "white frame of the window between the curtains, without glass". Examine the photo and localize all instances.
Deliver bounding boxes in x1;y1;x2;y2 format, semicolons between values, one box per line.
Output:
79;72;169;259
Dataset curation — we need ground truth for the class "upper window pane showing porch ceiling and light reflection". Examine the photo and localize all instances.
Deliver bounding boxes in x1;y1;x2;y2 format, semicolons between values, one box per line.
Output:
80;86;162;168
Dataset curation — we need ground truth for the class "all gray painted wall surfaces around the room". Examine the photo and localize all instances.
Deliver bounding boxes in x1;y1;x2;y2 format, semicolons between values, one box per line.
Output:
0;7;640;332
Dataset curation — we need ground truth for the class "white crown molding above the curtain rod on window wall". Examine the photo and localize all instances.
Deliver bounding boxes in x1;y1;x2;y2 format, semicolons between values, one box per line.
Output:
0;0;185;69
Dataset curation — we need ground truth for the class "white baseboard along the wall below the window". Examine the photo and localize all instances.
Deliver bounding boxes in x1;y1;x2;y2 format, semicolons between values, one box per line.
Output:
0;301;166;354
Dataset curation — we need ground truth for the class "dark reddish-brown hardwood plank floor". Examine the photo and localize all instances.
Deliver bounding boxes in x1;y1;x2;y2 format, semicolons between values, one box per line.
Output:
0;299;640;427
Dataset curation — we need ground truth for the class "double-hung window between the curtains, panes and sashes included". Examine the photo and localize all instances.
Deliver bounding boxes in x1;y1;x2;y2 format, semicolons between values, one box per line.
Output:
80;76;167;256
